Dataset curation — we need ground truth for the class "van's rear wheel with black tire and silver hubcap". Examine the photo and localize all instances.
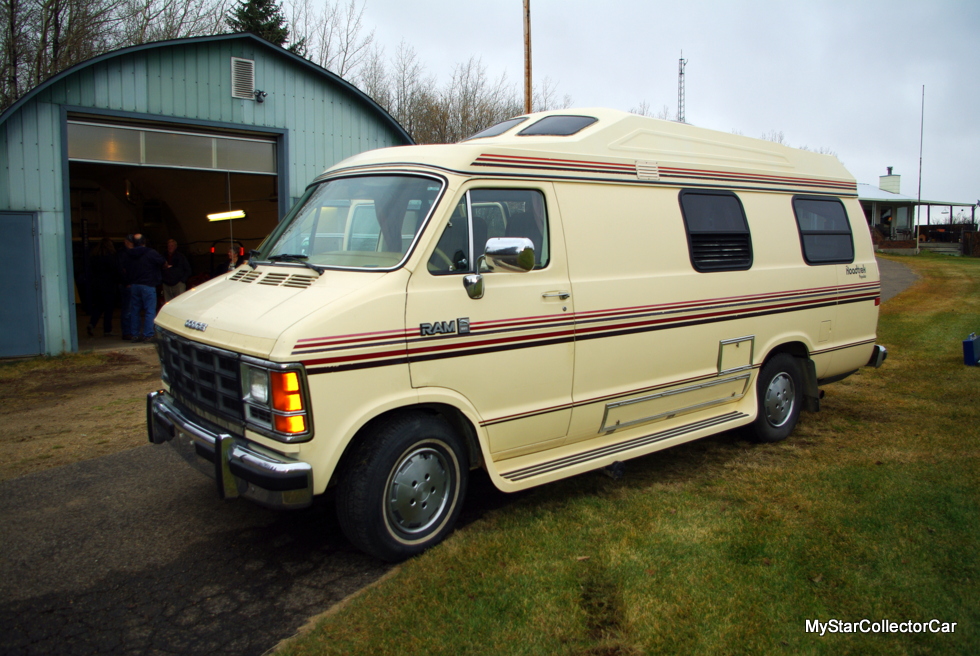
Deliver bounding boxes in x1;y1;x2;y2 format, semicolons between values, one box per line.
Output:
750;353;803;442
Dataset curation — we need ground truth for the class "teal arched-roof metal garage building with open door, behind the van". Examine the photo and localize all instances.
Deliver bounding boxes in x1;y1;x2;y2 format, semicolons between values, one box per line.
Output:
0;34;412;357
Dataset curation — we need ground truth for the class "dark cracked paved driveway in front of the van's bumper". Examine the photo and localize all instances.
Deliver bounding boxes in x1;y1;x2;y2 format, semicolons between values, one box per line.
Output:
0;445;390;656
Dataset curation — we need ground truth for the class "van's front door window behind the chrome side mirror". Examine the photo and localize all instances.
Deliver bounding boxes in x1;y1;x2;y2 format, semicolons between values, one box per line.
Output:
427;189;551;275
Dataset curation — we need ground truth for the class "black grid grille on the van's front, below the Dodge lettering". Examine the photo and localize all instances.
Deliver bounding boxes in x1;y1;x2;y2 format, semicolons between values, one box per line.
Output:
157;328;243;425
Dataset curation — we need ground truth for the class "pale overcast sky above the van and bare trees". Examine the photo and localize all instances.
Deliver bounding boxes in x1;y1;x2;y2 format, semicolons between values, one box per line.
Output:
363;0;980;211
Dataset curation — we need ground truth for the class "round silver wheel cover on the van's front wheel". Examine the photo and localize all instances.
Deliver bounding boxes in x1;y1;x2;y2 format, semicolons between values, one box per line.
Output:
385;447;452;534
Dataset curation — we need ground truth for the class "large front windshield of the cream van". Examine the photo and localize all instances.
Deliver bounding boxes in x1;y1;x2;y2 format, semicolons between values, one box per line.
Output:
262;175;443;269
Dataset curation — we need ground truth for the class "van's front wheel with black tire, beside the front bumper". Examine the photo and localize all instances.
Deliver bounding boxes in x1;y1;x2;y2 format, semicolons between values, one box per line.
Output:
337;412;469;562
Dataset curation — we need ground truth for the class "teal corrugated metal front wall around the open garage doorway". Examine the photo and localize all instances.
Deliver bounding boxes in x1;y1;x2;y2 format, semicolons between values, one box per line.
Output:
0;37;405;354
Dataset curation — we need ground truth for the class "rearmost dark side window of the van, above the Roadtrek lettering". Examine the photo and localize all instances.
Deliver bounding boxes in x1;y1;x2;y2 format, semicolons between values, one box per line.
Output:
793;196;854;264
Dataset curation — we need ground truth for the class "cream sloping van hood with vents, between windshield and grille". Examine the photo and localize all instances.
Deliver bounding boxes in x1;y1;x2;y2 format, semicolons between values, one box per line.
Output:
156;265;398;358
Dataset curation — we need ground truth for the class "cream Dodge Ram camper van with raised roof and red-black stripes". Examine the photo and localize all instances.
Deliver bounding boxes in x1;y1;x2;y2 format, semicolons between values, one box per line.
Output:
147;109;885;560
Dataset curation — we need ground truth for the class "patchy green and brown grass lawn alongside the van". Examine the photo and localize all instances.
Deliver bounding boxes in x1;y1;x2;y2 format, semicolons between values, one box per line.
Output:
278;255;980;656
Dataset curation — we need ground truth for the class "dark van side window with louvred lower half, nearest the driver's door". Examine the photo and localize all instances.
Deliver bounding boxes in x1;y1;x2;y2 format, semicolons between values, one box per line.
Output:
680;190;752;273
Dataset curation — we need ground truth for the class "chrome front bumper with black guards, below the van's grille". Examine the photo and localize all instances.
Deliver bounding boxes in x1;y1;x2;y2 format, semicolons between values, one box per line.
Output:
146;390;313;508
